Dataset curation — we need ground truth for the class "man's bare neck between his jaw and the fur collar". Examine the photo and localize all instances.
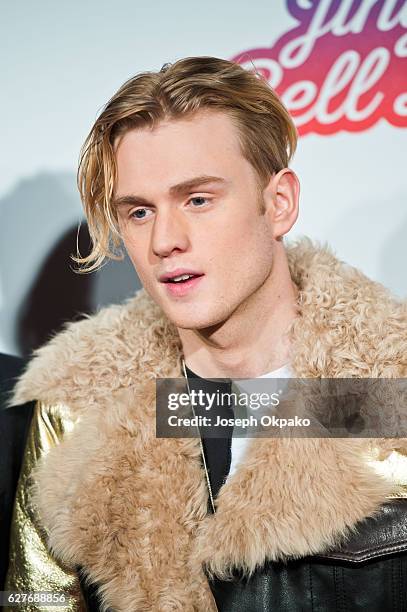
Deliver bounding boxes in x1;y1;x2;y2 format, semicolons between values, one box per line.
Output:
178;244;298;378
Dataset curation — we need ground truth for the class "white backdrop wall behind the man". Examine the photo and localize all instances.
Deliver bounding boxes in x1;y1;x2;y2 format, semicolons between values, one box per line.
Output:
0;0;407;353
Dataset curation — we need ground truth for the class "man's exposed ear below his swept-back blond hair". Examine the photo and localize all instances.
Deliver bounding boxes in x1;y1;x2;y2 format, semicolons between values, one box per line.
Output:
263;168;300;240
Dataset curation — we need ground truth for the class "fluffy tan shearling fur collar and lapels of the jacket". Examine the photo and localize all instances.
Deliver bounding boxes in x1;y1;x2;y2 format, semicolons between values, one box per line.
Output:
14;239;407;612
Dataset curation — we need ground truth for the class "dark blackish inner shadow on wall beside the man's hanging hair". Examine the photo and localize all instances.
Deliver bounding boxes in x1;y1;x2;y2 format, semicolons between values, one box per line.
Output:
16;224;140;356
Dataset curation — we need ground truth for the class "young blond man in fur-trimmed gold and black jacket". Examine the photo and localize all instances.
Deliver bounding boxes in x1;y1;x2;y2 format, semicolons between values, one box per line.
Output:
3;57;407;612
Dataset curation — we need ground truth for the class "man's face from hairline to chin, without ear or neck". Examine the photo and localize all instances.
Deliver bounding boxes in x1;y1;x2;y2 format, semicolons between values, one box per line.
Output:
115;111;273;329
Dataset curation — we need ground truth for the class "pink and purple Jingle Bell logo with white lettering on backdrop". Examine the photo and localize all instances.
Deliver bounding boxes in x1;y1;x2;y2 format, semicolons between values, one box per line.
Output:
232;0;407;135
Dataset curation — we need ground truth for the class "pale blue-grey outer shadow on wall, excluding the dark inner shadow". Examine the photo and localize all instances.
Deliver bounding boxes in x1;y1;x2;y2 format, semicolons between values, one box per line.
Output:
0;172;83;353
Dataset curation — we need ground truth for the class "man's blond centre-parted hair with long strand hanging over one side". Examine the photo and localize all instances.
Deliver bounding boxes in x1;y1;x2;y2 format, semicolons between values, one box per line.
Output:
75;57;297;271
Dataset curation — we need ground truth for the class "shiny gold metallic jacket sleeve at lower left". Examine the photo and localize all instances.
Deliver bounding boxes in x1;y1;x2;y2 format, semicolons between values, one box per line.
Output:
4;402;86;612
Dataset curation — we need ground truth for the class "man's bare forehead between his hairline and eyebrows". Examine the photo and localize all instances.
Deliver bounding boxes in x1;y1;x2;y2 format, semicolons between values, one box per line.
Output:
115;108;243;199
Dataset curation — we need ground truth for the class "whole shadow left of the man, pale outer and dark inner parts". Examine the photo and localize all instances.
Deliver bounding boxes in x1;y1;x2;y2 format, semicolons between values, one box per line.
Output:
0;172;140;355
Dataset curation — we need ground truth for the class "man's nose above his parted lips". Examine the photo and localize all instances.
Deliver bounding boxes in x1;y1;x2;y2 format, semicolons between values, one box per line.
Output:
151;210;189;257
